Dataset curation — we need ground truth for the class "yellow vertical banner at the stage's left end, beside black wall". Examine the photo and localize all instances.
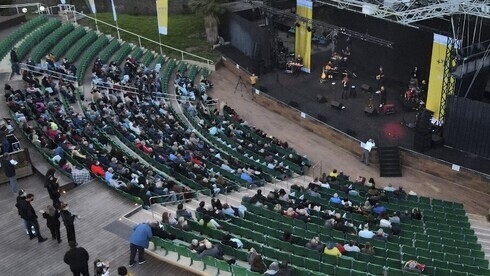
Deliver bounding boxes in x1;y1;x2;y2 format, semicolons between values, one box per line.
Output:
294;0;313;73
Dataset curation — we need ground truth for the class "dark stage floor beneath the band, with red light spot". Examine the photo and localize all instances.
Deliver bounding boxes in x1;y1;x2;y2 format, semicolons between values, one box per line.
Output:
258;52;490;174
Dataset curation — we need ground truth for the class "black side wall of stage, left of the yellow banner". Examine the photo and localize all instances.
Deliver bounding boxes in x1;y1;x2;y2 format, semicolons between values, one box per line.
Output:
219;9;271;73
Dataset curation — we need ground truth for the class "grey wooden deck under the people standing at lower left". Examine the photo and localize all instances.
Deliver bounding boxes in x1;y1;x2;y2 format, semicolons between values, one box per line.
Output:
0;174;192;275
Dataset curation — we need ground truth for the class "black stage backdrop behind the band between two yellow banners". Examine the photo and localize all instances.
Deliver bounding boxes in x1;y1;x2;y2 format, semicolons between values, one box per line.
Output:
313;6;433;83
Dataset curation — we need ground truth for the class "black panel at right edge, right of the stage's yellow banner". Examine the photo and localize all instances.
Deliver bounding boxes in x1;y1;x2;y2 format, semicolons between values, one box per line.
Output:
444;96;490;158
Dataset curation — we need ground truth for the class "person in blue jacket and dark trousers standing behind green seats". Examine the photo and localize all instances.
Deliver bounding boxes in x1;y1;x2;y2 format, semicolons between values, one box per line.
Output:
129;223;153;267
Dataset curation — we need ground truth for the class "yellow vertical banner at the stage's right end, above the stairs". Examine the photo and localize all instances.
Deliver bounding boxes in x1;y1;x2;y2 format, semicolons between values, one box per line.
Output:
426;34;448;119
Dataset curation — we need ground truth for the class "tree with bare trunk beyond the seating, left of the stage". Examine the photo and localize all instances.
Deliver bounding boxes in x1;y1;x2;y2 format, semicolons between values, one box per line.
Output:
189;0;225;44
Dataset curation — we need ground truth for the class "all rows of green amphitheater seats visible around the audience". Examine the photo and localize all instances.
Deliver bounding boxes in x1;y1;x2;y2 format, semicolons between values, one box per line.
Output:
6;17;490;276
